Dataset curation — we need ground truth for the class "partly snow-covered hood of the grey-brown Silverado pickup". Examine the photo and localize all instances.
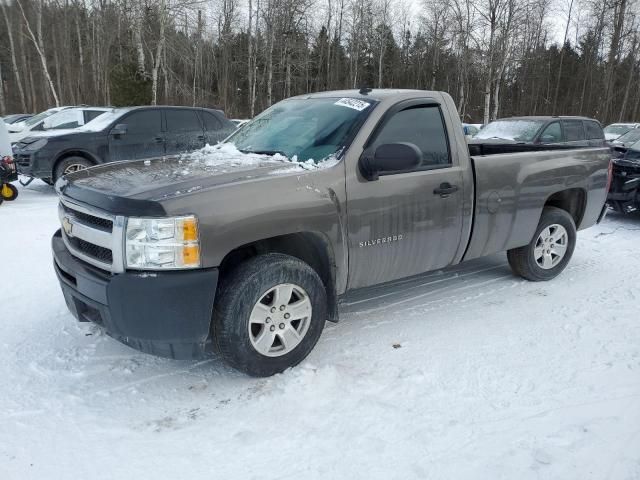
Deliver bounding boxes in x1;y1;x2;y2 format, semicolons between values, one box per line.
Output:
56;144;334;215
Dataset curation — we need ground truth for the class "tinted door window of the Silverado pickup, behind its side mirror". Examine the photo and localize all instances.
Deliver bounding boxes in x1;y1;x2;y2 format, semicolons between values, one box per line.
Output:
372;105;451;169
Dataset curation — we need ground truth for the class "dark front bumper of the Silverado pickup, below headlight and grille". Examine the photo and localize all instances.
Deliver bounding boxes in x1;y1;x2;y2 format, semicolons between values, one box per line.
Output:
52;230;218;359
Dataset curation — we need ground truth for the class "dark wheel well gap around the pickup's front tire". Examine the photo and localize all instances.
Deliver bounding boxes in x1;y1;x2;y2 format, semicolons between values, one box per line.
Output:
219;231;338;322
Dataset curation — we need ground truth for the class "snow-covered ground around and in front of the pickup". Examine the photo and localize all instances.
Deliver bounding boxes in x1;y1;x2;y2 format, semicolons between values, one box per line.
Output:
0;182;640;480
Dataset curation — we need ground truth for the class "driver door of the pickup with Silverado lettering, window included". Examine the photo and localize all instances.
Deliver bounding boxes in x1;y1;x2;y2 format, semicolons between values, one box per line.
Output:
347;99;464;288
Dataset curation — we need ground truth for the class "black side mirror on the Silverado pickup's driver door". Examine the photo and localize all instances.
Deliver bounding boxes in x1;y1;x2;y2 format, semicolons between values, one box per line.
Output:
359;142;422;180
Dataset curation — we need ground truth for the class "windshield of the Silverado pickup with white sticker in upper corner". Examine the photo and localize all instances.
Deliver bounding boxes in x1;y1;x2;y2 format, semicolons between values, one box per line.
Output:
227;98;373;162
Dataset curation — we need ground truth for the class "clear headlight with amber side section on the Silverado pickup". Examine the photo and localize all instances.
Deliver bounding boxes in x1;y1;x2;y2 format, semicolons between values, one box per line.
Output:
125;215;200;270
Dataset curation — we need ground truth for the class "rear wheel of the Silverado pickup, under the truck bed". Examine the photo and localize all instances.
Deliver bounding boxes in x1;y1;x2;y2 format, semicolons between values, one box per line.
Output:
507;207;576;282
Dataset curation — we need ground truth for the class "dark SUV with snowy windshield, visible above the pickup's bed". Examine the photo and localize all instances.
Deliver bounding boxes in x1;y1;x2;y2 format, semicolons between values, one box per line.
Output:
474;117;605;147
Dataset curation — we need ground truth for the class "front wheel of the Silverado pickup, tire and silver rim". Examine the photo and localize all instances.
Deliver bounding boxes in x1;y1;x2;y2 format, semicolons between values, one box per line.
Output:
212;253;327;377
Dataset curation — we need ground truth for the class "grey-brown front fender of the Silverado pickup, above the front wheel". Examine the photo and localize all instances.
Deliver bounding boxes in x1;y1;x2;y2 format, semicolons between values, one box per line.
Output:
163;162;348;293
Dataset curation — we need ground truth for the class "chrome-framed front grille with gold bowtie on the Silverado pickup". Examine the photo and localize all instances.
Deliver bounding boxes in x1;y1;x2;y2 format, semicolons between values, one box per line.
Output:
58;199;125;273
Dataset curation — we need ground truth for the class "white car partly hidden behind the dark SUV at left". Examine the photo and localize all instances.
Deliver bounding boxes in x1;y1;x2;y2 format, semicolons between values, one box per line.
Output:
8;107;111;145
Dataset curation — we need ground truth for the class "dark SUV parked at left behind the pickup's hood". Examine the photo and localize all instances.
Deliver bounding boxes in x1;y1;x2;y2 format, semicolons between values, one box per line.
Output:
13;106;235;183
